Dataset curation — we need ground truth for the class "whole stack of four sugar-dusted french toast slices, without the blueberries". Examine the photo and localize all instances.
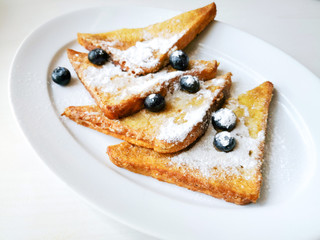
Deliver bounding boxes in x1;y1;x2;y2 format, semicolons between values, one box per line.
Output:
62;3;273;204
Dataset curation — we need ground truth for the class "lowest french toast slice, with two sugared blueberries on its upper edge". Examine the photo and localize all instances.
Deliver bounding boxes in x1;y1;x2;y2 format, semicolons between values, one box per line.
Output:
107;82;273;204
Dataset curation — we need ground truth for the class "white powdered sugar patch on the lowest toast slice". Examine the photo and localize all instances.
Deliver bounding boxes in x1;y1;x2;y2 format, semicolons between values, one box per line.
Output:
171;101;265;178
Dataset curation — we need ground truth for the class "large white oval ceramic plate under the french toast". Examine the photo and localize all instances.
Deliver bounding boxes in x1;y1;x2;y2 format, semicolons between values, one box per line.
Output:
10;6;320;239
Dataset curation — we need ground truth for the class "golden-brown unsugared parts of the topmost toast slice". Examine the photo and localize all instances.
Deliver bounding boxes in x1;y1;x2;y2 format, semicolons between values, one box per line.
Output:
78;3;216;75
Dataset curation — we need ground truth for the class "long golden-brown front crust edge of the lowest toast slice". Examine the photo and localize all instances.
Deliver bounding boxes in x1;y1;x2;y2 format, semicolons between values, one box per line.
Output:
107;142;258;205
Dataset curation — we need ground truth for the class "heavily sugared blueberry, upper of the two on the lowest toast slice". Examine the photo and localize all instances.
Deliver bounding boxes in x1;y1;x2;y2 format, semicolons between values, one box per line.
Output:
212;108;237;131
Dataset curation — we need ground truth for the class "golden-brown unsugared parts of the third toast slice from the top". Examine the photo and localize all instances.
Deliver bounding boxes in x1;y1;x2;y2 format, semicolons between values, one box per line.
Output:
62;73;231;153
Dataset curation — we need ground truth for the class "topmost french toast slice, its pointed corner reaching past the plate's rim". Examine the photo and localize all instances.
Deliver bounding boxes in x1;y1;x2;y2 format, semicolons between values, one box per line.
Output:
78;3;216;75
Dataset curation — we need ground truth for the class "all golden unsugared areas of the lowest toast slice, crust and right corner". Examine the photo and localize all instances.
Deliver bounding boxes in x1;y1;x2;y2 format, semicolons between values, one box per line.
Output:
107;82;273;204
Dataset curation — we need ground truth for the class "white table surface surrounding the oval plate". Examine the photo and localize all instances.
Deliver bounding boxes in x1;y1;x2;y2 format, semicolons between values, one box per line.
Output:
0;0;320;240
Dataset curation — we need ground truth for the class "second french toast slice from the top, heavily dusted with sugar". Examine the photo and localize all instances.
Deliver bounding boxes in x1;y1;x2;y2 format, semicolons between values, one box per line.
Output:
67;49;218;119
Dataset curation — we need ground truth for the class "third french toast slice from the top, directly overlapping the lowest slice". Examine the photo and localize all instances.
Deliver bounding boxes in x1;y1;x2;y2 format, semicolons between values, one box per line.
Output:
62;73;231;153
